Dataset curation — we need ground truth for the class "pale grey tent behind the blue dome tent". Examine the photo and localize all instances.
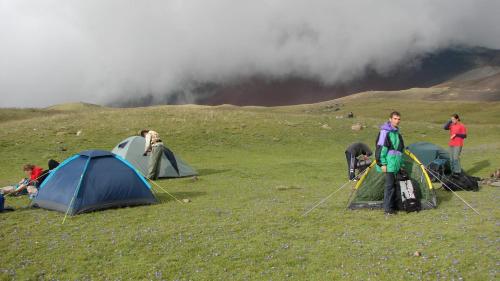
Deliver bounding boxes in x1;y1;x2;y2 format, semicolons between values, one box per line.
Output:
111;136;198;178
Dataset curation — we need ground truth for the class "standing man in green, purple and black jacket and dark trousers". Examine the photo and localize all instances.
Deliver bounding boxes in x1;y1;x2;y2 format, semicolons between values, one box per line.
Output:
375;111;405;215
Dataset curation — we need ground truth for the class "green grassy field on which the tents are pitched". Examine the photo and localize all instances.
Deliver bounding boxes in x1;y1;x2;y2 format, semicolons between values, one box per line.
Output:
0;90;500;280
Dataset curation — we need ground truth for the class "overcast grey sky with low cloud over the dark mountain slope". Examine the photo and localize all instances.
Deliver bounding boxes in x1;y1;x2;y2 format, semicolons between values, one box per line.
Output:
0;0;500;107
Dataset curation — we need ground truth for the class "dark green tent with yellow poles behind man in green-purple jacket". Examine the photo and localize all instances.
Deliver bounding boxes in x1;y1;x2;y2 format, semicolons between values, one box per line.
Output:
349;150;437;209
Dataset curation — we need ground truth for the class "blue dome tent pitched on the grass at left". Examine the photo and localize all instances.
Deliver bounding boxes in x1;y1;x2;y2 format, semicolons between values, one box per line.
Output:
33;150;157;215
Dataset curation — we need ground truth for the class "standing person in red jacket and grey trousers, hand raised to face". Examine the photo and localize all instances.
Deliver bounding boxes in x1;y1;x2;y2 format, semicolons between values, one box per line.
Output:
444;114;467;174
